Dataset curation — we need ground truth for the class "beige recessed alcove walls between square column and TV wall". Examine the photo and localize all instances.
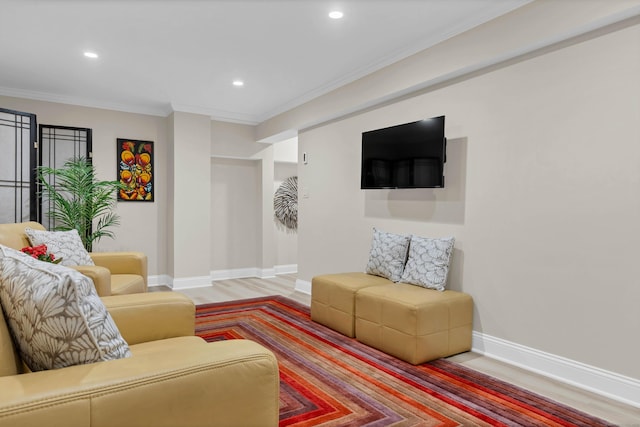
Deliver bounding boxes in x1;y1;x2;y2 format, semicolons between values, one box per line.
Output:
211;121;297;278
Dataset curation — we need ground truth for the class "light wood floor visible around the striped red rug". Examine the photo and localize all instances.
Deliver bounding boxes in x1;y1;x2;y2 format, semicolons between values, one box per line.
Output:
164;275;640;427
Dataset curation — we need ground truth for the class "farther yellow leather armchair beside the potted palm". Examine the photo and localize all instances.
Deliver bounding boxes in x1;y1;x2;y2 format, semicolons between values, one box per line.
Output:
0;222;147;296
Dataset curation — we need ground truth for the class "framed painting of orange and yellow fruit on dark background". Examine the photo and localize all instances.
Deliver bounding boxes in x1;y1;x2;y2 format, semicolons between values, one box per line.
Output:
118;138;155;202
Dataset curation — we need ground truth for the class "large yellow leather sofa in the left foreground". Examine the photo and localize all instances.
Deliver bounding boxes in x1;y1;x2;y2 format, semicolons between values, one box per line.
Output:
0;292;279;427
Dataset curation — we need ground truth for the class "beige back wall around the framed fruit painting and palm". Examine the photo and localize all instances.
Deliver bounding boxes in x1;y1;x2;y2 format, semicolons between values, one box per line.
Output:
0;96;168;275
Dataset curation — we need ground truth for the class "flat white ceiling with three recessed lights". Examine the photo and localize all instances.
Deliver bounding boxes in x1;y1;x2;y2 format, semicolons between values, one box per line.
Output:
0;0;528;123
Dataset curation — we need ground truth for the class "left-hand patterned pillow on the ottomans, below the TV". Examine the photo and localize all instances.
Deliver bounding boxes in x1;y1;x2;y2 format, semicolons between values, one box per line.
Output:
366;228;410;282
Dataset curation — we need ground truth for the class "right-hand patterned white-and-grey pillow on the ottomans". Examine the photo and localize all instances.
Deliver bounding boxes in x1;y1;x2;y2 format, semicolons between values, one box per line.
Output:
401;236;455;291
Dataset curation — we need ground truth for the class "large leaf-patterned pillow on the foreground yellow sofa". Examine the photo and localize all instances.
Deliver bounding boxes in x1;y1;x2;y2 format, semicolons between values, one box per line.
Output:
0;245;131;371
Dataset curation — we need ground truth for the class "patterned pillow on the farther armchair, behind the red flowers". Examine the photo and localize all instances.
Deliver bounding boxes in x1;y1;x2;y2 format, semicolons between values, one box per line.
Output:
24;227;95;266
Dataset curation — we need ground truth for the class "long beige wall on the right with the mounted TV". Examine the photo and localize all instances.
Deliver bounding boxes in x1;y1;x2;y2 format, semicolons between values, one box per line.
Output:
298;20;640;379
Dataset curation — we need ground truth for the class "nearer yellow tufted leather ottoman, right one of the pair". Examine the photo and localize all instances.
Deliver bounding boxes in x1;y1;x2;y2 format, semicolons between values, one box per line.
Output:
355;283;473;365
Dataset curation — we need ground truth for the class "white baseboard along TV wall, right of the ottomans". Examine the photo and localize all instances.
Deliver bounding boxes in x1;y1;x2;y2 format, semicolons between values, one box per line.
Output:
472;331;640;407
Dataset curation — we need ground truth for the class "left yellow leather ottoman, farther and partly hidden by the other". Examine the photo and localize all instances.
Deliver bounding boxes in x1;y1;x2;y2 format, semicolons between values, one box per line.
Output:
311;273;393;338
